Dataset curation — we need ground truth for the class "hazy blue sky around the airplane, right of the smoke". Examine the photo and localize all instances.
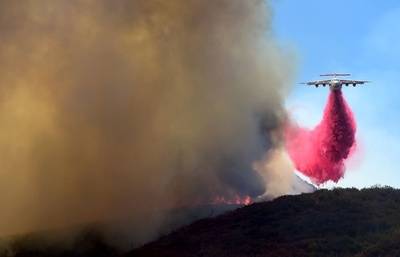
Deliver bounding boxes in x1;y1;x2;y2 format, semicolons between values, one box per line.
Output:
272;0;400;188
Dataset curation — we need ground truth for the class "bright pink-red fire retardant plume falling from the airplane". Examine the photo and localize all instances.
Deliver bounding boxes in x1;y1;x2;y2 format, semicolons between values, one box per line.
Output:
285;90;356;185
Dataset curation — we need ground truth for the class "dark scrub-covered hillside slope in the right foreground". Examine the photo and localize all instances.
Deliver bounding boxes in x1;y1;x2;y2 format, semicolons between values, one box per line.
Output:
128;187;400;256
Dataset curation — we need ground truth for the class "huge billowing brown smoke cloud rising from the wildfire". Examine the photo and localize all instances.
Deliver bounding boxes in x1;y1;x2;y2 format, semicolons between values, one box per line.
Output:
0;0;293;235
